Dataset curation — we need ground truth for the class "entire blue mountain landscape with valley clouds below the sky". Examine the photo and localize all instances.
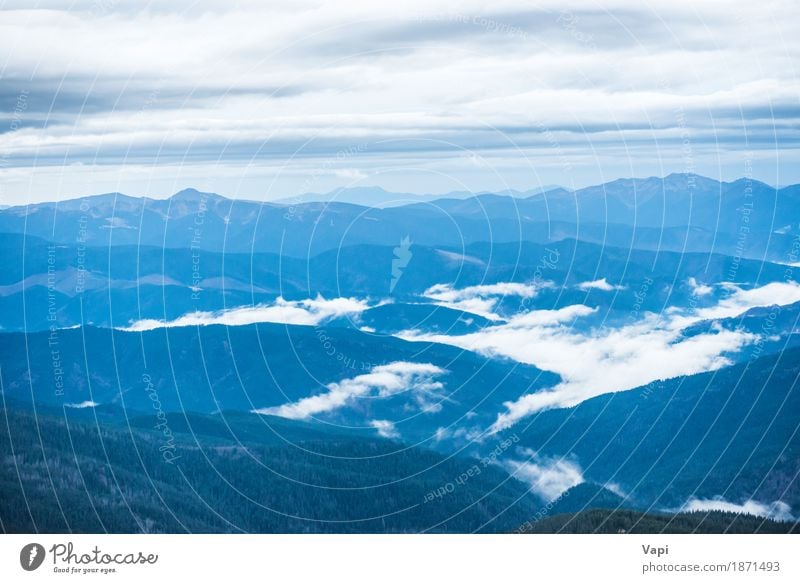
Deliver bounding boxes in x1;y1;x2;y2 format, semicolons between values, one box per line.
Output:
0;174;800;532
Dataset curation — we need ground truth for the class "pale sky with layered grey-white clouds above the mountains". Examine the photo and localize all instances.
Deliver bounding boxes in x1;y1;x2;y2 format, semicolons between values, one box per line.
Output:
0;0;800;205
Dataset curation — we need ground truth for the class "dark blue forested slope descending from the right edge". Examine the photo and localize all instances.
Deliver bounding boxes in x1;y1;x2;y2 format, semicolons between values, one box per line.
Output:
507;349;800;511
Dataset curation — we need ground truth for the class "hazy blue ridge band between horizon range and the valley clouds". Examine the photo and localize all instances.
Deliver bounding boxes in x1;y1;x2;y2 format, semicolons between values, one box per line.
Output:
0;234;798;331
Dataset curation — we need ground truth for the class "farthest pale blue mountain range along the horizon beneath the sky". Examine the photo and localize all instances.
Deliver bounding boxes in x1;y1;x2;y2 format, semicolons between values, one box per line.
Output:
0;174;800;261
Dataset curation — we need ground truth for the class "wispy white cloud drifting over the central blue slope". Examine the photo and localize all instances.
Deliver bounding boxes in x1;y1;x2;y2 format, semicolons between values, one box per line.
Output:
253;361;446;420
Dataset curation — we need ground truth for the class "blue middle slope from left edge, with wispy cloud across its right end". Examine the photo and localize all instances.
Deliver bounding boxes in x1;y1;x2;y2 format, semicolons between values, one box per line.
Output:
0;324;558;446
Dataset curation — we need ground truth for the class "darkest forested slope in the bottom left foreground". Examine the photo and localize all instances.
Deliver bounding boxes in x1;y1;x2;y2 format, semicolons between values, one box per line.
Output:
0;408;539;533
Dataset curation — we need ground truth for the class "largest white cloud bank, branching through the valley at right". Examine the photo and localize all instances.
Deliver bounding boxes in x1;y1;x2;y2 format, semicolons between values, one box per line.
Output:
398;283;800;432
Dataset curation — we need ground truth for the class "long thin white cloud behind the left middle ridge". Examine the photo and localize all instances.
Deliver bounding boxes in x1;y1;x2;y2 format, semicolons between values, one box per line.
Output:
122;296;369;332
